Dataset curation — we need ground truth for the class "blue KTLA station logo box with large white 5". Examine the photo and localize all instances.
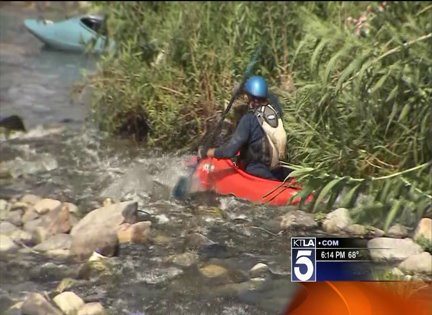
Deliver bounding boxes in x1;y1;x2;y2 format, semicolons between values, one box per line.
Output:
291;237;316;282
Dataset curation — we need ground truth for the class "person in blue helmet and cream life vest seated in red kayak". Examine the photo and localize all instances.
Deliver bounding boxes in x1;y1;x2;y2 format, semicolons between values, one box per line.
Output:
198;76;286;180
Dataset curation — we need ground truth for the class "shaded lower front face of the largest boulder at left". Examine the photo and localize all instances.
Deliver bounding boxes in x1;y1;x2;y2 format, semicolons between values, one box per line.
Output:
71;230;118;260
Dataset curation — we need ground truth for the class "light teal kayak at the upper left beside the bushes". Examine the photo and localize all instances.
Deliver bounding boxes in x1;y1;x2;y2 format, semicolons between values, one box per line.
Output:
24;15;115;53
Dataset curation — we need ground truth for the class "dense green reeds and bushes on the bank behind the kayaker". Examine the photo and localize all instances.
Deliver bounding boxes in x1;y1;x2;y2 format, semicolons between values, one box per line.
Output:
85;1;432;229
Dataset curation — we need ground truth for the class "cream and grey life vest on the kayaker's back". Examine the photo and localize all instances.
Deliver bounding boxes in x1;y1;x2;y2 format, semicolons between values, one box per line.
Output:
254;104;287;169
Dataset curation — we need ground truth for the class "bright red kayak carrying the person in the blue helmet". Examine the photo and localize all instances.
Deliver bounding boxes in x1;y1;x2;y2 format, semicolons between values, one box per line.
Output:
188;157;308;206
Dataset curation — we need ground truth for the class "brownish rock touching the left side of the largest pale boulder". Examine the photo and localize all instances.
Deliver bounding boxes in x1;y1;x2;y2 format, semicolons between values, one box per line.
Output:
34;207;72;242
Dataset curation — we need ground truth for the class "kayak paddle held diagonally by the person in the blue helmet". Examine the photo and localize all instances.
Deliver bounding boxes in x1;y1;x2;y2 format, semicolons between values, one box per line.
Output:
173;47;261;199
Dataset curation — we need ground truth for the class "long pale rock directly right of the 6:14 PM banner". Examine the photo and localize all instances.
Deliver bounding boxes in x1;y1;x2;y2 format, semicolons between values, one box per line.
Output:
367;237;423;261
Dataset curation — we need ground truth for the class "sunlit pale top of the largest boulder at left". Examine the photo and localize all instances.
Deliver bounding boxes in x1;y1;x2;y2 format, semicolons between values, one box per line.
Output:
71;201;138;236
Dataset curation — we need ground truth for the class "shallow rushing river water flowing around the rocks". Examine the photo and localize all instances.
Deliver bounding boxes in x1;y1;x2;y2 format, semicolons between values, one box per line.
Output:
0;6;314;314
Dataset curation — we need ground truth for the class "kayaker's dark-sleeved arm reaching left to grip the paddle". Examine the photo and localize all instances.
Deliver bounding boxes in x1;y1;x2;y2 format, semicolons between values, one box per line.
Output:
207;113;251;159
